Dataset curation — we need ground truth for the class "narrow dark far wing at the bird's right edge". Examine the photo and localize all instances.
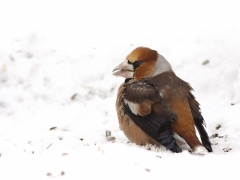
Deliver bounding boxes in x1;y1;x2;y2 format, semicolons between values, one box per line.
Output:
188;92;212;152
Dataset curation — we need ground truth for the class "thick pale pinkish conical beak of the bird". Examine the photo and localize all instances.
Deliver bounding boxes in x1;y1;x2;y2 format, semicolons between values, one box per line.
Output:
113;60;134;78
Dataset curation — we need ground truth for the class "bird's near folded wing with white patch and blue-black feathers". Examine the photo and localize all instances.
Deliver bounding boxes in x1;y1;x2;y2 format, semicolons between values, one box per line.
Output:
123;81;182;152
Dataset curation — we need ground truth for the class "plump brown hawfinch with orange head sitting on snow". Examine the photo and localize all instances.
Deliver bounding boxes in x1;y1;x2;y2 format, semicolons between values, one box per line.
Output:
113;47;212;154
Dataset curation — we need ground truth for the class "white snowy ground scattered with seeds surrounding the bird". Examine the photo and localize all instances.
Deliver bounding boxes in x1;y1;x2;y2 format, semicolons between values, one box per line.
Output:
0;0;240;180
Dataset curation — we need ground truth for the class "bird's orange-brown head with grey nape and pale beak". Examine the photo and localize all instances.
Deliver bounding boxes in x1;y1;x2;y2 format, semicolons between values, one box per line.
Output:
113;47;172;80
